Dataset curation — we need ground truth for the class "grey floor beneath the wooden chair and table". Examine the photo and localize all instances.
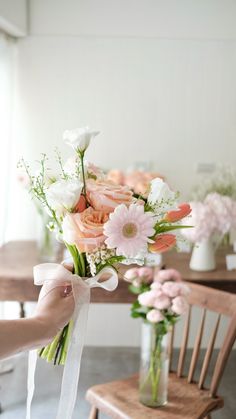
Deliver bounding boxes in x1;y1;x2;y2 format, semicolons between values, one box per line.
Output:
0;347;236;419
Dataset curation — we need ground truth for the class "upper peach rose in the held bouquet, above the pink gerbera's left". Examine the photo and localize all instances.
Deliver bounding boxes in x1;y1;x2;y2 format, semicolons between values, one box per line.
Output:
86;179;133;212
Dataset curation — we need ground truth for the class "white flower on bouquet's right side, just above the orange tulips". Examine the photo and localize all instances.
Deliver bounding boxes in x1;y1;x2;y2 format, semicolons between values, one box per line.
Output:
148;178;176;212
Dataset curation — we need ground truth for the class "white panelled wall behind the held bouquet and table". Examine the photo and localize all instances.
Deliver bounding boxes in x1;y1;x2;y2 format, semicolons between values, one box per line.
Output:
8;0;236;344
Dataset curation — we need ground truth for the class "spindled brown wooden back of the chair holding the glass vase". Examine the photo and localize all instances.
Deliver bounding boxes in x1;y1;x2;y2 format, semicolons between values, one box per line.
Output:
170;283;236;397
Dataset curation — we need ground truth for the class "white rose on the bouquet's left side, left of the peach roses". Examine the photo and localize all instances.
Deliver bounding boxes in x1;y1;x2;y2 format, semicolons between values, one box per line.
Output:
46;180;83;216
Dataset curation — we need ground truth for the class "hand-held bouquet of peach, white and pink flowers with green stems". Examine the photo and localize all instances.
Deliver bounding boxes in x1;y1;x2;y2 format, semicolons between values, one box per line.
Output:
21;127;191;364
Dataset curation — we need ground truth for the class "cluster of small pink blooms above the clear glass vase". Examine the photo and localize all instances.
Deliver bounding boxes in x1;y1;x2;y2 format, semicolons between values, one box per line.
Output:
125;267;190;328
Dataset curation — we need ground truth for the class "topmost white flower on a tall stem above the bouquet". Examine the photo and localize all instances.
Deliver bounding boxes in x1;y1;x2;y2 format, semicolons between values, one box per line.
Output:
63;127;99;153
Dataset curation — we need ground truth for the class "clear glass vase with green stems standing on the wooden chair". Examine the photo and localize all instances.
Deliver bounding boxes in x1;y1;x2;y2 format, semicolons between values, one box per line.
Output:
139;322;169;407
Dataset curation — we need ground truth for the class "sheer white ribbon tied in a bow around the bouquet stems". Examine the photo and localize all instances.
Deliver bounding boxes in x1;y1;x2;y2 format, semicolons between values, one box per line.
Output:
26;263;118;419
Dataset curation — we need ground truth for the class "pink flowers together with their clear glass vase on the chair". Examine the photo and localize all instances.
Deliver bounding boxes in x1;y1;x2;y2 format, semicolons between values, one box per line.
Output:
125;267;189;407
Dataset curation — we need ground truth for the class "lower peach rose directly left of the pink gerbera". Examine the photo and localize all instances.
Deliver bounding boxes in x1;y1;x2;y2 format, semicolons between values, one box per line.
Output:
62;207;109;252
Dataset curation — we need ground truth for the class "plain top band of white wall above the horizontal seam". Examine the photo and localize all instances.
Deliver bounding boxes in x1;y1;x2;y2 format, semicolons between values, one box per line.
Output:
30;0;236;39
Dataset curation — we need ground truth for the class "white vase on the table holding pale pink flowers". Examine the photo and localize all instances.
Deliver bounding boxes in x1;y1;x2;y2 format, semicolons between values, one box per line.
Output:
189;238;216;271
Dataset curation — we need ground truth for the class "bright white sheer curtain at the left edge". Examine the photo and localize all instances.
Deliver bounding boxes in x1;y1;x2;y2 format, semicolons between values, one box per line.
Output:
0;32;16;245
